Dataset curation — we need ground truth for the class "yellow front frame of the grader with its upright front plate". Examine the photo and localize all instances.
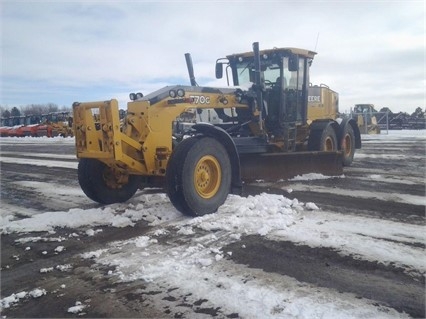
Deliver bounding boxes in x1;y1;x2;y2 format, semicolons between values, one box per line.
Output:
73;86;247;176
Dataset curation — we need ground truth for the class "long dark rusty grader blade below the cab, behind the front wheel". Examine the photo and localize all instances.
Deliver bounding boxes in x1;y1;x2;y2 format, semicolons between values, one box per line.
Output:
240;152;343;182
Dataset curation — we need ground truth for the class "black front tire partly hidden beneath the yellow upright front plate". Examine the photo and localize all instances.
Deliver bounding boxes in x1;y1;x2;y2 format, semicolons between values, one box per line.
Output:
78;158;142;204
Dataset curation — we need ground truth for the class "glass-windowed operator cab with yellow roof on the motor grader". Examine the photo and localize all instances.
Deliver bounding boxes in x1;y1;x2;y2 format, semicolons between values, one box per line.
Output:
216;48;316;137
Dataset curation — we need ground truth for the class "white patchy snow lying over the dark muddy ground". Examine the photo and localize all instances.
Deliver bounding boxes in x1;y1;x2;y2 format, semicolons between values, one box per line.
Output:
0;131;426;319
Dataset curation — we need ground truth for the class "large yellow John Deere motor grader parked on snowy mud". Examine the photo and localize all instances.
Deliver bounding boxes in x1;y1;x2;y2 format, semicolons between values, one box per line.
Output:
73;42;361;216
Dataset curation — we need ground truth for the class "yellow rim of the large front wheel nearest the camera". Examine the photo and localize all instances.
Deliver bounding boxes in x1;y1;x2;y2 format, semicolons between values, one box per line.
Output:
194;155;222;198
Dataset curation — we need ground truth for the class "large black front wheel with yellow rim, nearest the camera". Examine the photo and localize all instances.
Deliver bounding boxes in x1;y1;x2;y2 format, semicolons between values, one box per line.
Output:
166;137;231;216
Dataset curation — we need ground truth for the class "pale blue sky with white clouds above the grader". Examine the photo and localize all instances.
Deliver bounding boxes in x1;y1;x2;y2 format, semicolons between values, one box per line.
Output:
0;0;426;113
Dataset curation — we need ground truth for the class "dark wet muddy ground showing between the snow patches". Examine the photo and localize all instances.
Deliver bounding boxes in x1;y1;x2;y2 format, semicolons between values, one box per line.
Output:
1;139;425;318
